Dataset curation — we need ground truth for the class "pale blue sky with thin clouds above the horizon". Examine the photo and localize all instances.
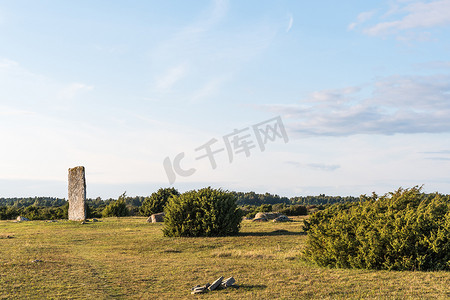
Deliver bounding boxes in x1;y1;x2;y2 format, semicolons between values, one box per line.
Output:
0;0;450;199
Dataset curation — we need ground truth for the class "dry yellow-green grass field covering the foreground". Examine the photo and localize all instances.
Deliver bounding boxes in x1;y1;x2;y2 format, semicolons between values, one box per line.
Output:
0;218;450;299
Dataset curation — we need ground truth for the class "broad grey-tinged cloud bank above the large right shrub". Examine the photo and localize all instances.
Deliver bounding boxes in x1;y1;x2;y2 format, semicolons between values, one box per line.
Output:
264;75;450;136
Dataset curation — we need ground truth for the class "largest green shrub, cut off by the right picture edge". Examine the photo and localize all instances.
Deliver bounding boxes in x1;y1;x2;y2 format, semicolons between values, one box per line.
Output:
304;187;450;270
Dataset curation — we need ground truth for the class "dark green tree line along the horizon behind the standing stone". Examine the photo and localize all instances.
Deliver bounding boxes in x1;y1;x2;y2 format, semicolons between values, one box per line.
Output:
0;188;359;220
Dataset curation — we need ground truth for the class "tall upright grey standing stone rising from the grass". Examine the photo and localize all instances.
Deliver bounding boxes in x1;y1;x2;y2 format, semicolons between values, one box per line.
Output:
69;167;86;221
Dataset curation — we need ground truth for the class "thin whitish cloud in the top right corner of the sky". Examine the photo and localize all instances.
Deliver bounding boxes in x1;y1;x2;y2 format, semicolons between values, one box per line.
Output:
349;0;450;40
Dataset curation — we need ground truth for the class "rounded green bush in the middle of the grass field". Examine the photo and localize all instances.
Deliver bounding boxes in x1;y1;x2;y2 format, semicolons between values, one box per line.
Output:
163;187;242;237
